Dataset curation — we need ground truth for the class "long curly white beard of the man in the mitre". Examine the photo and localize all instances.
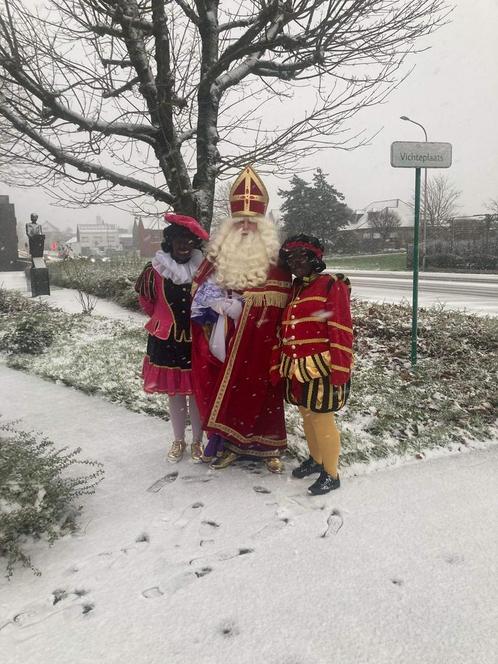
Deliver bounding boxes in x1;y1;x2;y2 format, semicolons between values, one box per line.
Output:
208;220;279;291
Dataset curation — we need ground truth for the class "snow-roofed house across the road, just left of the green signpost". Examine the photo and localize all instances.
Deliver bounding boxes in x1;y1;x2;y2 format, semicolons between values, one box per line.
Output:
339;198;414;252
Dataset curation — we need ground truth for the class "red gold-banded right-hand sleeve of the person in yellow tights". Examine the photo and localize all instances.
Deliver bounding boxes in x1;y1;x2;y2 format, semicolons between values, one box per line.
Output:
327;274;353;385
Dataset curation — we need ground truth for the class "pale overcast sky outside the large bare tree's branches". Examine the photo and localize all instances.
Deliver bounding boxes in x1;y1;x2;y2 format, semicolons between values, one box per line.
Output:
0;0;498;227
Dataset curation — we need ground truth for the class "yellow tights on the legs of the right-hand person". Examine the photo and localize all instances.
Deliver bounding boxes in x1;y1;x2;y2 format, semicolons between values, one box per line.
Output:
299;406;341;478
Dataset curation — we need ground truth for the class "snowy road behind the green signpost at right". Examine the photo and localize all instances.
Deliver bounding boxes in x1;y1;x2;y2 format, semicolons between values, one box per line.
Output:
338;270;498;316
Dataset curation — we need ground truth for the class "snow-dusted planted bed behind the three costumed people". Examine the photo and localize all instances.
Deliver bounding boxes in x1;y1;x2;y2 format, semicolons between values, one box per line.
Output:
0;291;498;467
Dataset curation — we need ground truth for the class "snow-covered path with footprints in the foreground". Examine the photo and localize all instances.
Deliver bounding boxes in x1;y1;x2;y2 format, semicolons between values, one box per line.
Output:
0;367;498;664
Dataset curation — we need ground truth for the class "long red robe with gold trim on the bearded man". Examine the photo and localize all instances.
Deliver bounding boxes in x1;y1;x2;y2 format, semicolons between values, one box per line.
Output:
192;261;291;457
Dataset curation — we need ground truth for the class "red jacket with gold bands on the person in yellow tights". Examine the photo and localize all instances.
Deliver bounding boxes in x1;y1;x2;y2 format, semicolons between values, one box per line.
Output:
277;274;353;385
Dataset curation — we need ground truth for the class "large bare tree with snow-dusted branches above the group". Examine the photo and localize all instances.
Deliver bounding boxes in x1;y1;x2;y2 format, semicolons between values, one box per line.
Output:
0;0;449;225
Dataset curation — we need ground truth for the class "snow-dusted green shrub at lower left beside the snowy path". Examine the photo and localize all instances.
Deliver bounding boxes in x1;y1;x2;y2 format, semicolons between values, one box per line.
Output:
0;425;104;576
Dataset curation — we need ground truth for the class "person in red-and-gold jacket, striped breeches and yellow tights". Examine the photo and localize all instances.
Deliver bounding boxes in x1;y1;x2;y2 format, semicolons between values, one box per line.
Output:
278;235;353;495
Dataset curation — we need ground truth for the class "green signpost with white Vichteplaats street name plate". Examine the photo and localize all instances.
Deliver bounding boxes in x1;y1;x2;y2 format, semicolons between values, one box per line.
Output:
391;141;452;367
